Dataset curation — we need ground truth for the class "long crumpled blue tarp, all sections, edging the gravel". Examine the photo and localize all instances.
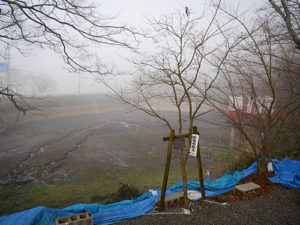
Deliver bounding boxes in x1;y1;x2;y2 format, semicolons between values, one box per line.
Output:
0;160;300;225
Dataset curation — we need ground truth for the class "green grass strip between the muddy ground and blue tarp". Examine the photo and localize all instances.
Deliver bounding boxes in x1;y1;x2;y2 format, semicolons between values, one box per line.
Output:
0;149;238;215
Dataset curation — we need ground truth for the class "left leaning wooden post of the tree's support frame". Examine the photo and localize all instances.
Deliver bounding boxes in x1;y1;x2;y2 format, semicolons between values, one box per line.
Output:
158;130;175;212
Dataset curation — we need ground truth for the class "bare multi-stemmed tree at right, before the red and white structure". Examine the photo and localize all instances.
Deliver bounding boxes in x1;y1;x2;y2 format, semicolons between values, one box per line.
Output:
208;6;300;172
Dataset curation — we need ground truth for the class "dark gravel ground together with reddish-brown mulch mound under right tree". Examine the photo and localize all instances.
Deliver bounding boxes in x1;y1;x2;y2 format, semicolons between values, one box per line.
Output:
121;173;300;225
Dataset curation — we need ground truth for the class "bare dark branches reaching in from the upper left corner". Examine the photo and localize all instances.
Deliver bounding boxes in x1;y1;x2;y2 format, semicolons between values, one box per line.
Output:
0;0;137;110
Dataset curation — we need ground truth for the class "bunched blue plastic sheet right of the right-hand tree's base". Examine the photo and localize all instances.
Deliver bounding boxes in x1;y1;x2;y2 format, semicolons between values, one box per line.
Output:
269;159;300;189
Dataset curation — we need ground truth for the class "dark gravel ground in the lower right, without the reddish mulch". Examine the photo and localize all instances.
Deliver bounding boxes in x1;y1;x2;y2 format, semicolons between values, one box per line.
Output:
120;186;300;225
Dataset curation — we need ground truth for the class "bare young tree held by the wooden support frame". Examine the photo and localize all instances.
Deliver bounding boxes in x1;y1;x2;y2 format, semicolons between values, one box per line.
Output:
106;2;240;209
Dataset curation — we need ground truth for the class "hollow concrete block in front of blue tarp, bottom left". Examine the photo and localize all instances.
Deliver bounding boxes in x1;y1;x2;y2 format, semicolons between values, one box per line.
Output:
55;212;93;225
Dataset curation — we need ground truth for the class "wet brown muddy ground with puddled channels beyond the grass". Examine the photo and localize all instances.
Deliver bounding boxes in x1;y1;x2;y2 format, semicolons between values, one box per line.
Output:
0;95;229;188
